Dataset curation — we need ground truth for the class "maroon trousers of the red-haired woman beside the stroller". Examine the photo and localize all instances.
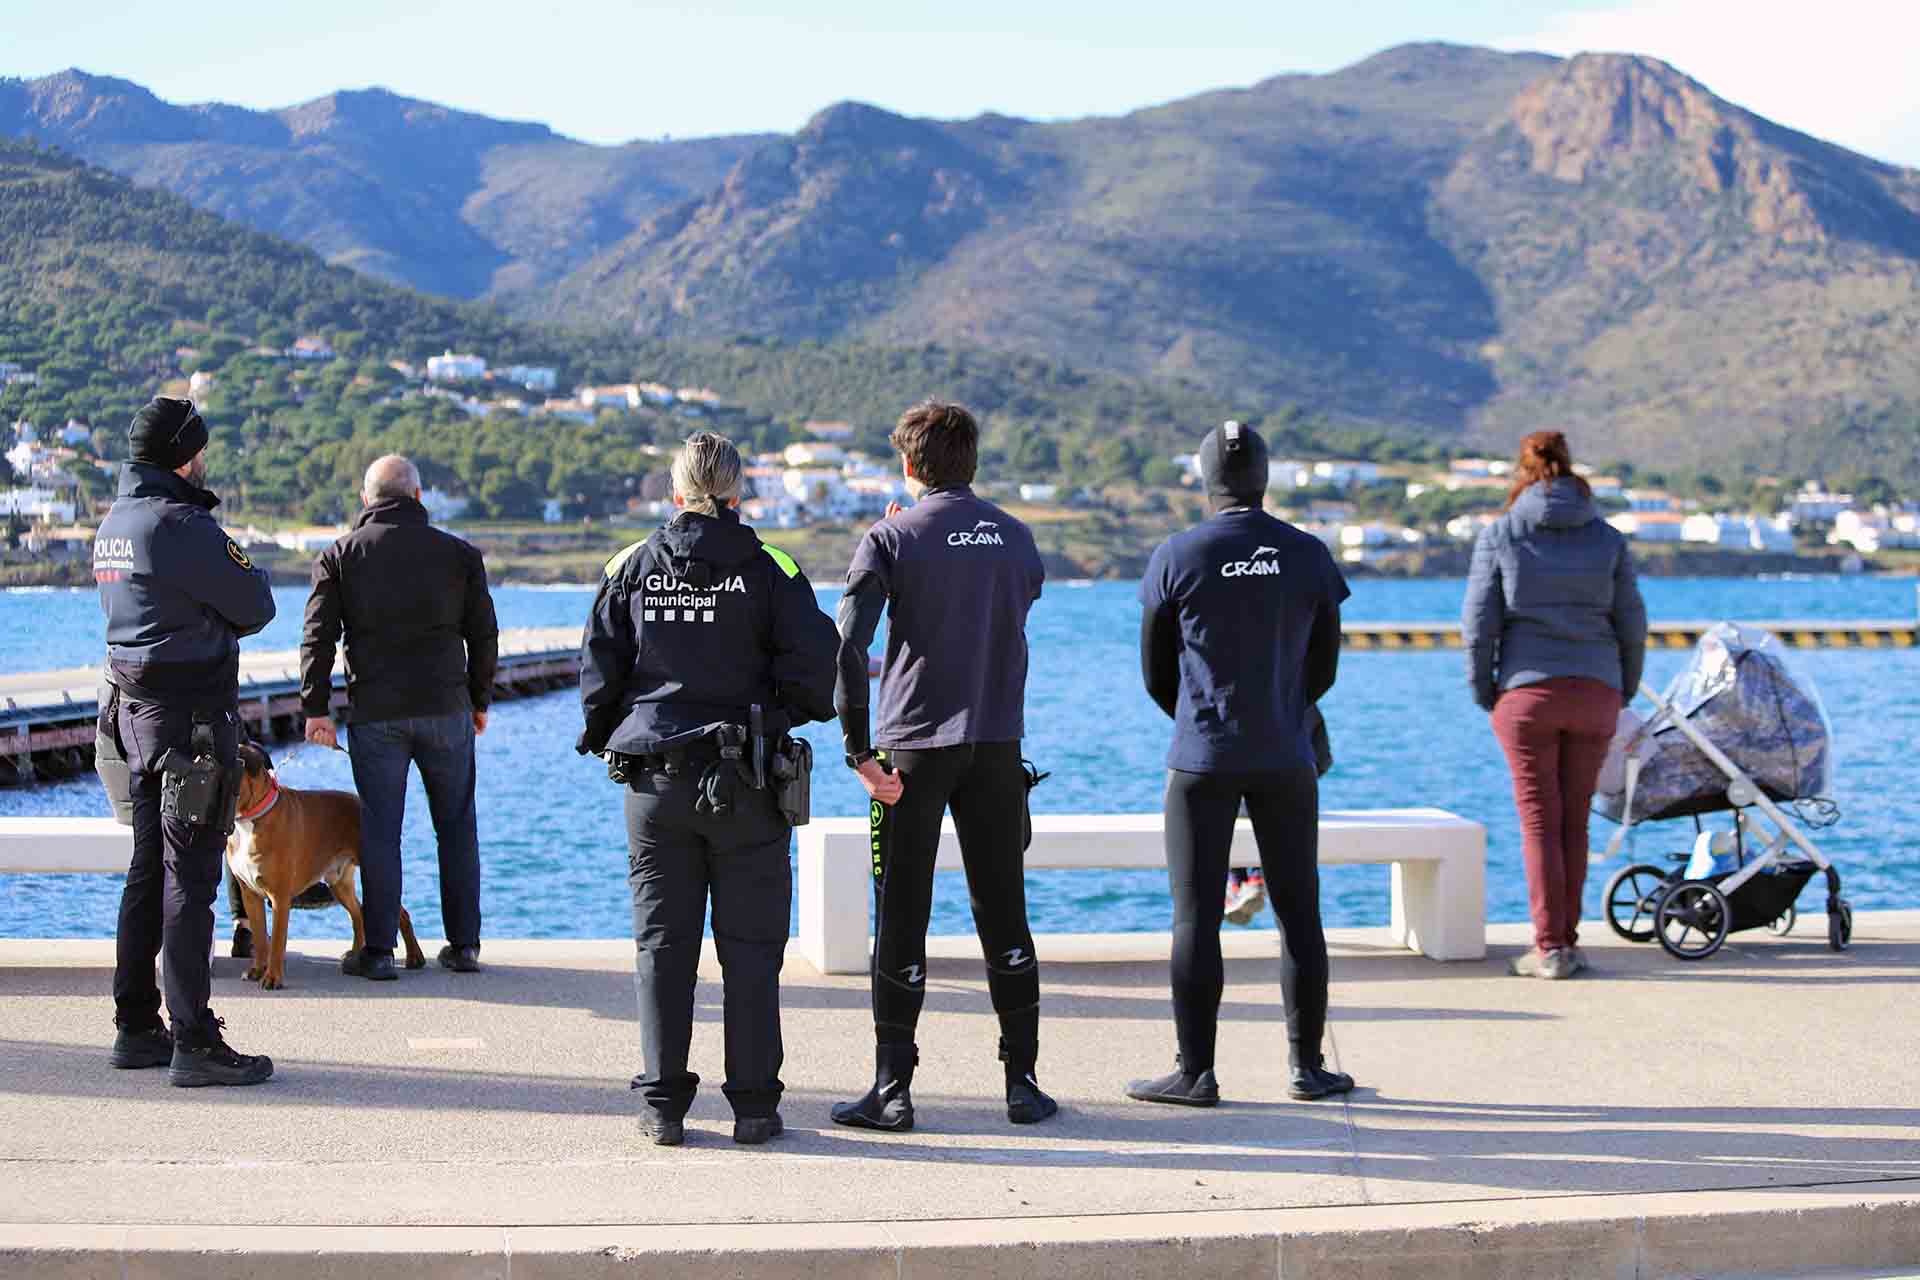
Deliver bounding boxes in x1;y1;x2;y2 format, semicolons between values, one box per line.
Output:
1494;676;1620;952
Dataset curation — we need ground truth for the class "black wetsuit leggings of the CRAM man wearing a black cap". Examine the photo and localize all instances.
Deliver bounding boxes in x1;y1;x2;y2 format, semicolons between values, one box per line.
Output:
1165;766;1327;1073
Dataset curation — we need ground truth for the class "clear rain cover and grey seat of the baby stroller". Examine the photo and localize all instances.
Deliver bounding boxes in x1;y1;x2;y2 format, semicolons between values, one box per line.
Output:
1596;622;1834;823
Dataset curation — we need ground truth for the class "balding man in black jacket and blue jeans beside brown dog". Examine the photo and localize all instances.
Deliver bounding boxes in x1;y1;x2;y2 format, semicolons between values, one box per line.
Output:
300;455;499;983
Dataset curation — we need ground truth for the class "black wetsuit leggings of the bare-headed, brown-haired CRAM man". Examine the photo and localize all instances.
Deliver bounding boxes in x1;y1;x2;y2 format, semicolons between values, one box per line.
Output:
872;743;1041;1054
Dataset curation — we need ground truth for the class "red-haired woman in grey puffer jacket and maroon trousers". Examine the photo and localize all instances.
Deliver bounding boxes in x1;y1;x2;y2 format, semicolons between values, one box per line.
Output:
1461;432;1647;979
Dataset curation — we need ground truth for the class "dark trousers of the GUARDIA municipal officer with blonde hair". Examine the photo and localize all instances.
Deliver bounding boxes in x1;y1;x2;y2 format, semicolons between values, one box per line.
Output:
626;766;793;1119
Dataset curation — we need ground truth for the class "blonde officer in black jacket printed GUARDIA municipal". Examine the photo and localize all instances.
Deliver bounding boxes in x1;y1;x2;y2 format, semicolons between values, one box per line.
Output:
578;432;839;1146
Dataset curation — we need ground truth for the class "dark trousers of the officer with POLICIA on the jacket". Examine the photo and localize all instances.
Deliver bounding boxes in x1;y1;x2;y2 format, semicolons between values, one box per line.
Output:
113;699;240;1044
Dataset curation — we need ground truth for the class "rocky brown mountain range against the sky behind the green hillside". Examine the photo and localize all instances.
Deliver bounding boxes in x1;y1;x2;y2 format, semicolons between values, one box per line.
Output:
0;44;1920;472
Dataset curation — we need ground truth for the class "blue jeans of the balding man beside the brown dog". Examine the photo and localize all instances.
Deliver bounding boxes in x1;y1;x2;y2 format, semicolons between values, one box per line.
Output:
348;712;480;954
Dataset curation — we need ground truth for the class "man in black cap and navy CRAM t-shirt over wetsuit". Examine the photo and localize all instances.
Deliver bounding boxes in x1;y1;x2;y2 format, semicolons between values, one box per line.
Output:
1127;422;1354;1107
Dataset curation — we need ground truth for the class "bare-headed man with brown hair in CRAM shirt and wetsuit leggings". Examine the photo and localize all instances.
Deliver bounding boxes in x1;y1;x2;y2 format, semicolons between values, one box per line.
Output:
833;401;1060;1132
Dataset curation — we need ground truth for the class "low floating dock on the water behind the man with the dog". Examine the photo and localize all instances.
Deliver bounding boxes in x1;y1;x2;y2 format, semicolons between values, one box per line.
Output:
0;628;580;787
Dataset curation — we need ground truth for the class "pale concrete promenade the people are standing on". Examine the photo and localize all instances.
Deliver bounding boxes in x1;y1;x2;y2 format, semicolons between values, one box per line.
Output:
0;912;1920;1280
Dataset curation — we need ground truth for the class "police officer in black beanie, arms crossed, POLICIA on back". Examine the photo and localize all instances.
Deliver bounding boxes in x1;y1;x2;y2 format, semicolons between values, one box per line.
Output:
94;399;273;1086
